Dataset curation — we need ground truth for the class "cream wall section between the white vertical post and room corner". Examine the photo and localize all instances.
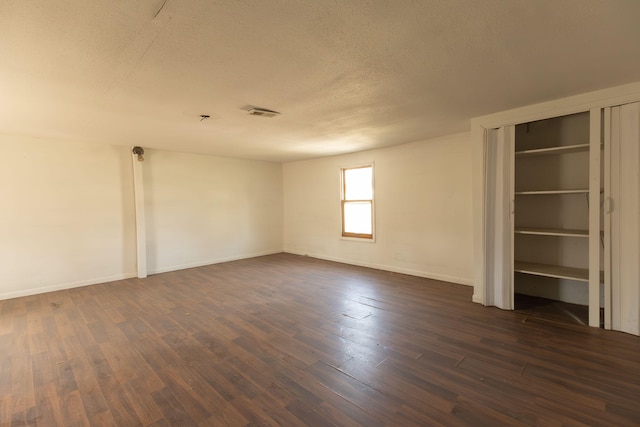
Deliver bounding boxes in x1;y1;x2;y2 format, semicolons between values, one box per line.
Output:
142;150;283;273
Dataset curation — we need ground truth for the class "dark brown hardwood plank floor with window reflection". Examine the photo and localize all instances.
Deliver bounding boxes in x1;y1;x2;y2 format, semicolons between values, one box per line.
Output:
0;254;640;426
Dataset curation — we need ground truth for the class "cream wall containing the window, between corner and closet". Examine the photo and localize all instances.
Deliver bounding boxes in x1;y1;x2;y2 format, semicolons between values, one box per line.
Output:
283;133;473;284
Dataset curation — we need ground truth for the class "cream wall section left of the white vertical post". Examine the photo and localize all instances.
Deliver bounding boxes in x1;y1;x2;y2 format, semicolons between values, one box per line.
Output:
0;135;135;299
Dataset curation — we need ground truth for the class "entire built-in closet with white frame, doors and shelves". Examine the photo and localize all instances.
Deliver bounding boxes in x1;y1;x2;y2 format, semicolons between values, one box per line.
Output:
478;93;640;335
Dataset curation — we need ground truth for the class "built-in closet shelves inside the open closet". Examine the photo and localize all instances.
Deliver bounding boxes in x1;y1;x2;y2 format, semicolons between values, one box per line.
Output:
513;112;600;324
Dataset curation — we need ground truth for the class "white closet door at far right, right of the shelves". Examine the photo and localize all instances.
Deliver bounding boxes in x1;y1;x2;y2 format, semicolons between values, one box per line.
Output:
605;102;640;335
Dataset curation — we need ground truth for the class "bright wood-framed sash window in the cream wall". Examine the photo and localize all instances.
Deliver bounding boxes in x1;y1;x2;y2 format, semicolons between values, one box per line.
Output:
341;165;373;239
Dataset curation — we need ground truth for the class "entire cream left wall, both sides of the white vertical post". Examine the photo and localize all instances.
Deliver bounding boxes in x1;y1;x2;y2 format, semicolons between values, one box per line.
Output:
0;139;282;299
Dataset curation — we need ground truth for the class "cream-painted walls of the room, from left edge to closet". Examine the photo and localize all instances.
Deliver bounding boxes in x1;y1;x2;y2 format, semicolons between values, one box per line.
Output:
0;133;472;299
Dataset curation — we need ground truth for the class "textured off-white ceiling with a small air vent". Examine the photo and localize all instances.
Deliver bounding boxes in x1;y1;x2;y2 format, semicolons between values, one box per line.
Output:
0;0;640;161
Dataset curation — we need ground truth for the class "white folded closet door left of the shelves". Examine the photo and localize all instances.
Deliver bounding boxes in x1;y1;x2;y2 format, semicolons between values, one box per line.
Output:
484;126;515;310
